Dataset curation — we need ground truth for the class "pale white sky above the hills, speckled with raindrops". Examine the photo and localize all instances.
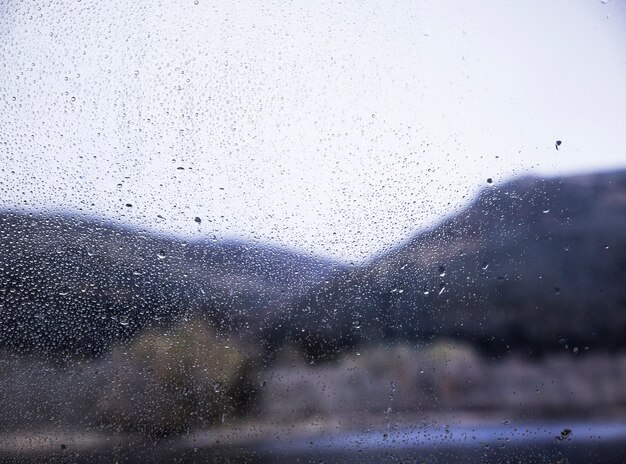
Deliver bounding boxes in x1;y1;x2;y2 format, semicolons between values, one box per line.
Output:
0;0;626;261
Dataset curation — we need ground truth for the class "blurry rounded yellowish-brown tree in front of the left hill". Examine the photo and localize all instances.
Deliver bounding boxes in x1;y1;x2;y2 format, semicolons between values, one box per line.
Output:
98;316;253;436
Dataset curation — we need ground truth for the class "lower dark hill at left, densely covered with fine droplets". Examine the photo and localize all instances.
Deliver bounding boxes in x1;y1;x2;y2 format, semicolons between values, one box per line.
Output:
0;211;341;355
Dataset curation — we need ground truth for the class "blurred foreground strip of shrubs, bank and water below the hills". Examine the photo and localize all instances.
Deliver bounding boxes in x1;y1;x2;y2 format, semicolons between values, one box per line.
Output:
0;317;626;462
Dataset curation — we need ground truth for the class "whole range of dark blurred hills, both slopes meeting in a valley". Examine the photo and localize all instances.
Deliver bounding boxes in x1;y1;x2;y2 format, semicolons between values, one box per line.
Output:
0;171;626;359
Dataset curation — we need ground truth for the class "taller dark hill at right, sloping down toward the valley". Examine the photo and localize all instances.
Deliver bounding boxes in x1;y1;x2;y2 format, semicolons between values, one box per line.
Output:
265;171;626;358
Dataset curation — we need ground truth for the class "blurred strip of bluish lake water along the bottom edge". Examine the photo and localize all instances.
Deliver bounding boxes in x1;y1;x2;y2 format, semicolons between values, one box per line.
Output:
6;422;626;464
